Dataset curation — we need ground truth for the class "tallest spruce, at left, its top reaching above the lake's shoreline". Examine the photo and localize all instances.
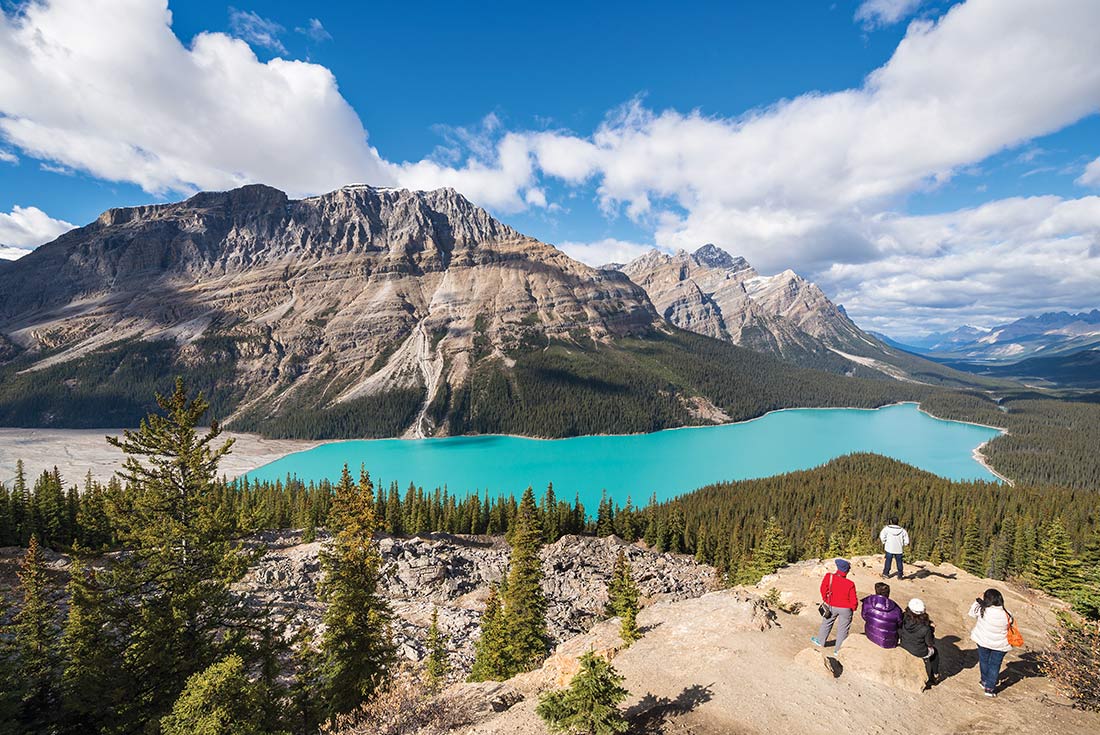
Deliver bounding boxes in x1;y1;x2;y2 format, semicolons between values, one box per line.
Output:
105;380;253;732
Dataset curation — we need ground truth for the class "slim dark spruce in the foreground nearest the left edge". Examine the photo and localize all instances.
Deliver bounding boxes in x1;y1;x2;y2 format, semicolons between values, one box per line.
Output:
12;536;59;733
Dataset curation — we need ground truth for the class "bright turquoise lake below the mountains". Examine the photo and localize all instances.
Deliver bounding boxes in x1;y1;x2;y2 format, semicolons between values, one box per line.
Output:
248;404;1001;508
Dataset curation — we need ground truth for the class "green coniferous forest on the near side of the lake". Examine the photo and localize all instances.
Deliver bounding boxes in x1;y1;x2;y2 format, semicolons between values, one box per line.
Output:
0;381;1100;733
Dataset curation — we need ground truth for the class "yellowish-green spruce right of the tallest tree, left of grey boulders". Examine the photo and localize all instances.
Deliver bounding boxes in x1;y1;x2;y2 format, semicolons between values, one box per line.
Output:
318;465;397;717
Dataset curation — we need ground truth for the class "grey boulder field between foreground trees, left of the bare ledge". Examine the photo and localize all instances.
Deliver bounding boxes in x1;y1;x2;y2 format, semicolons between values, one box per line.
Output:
240;533;716;669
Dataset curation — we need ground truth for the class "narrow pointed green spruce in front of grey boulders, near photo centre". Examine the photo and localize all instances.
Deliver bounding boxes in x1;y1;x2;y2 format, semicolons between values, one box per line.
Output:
502;487;549;677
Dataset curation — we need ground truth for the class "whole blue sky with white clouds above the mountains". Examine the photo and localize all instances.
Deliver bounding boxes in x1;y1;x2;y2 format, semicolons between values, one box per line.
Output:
0;0;1100;334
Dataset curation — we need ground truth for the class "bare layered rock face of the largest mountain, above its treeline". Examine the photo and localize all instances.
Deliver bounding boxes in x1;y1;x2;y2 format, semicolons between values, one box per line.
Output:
0;185;662;436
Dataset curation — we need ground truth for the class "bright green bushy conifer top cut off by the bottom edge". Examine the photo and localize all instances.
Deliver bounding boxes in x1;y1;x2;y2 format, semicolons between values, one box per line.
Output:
161;655;273;735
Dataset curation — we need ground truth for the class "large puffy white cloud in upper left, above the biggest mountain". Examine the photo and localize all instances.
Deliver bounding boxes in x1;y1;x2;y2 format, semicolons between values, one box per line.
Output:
0;0;393;195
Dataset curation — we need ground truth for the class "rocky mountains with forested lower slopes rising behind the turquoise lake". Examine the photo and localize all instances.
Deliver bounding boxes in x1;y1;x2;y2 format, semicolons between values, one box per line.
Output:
0;185;937;438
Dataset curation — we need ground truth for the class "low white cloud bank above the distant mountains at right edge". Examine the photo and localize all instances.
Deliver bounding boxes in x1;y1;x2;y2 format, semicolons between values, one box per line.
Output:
818;196;1100;334
